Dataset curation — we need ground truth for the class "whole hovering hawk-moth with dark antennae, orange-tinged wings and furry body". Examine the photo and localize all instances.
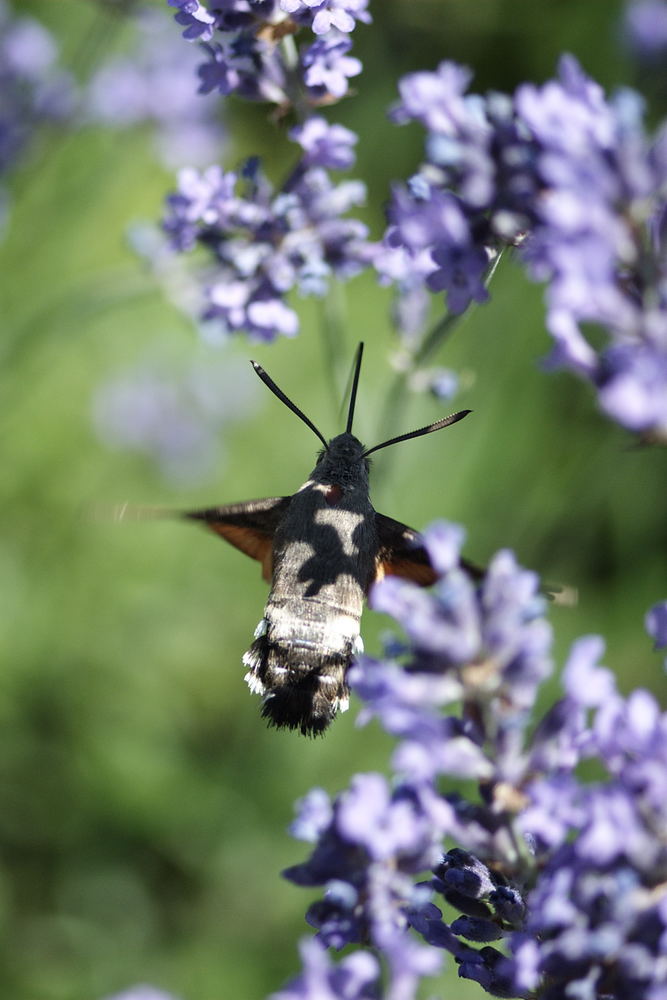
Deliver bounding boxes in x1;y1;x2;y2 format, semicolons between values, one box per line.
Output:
175;344;471;736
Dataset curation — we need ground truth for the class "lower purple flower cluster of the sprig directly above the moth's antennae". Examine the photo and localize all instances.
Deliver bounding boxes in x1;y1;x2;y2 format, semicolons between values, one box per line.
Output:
165;163;372;340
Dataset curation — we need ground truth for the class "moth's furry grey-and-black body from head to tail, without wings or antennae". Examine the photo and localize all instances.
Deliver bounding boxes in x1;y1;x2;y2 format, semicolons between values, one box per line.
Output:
243;433;379;734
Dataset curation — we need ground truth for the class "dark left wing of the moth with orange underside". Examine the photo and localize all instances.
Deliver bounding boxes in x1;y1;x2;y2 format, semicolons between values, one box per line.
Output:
187;497;292;582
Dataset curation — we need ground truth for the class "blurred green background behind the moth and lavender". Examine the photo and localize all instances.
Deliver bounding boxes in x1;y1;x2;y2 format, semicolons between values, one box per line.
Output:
0;0;667;1000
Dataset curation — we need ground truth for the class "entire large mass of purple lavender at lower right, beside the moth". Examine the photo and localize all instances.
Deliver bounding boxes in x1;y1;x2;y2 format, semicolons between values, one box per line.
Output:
278;524;667;1000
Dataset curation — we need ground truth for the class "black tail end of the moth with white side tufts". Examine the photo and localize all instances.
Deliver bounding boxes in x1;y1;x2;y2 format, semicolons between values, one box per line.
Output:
243;632;353;736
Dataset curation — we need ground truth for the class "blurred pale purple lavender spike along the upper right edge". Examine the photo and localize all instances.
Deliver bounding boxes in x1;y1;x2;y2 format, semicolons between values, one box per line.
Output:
516;58;667;431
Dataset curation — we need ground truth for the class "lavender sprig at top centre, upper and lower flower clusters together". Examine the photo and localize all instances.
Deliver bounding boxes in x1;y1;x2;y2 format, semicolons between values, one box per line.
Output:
164;0;373;340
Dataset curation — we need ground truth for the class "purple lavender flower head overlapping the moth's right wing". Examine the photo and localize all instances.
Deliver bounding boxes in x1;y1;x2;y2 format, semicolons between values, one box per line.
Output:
349;524;551;796
